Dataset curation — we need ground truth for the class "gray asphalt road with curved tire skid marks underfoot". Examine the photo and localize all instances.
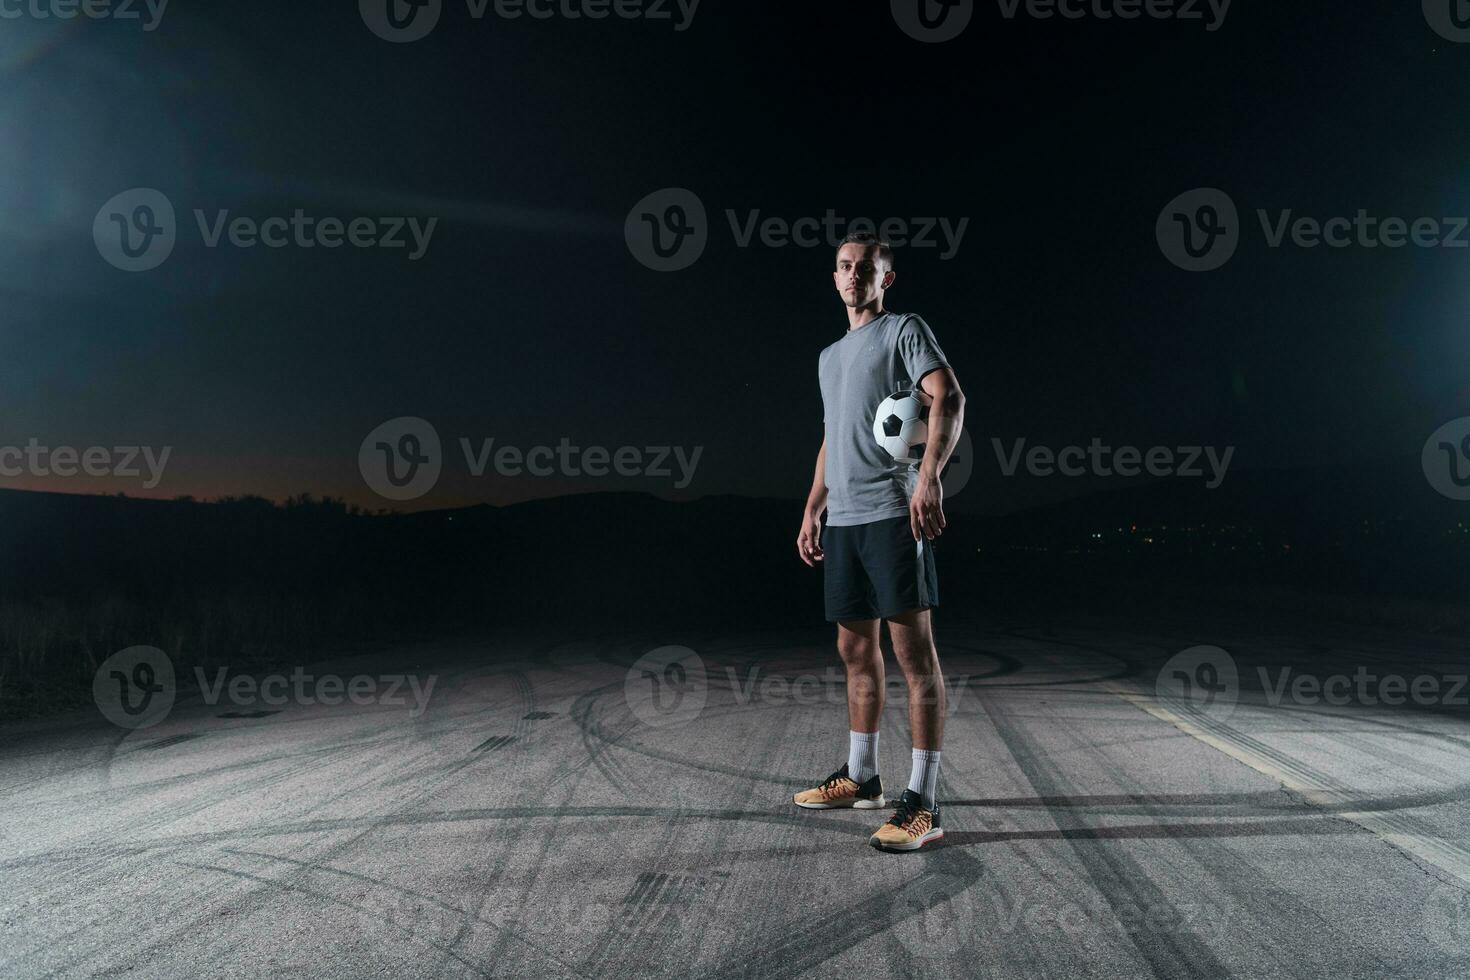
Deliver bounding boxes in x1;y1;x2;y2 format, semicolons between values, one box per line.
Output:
0;608;1470;980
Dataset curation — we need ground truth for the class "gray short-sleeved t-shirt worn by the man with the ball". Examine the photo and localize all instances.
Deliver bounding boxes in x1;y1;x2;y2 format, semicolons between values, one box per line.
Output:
817;313;950;527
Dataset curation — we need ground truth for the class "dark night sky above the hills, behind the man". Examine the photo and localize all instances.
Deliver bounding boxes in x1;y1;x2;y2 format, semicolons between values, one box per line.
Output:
0;0;1470;522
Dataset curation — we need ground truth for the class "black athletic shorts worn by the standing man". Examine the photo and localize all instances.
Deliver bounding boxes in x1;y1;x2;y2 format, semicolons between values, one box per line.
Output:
820;514;939;623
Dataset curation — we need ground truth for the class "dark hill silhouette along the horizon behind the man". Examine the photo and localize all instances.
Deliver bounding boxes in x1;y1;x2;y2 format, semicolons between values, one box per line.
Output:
0;460;1470;717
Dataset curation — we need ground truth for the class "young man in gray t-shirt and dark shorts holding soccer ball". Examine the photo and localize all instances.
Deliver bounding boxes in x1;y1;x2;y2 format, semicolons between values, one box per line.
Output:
794;235;964;851
